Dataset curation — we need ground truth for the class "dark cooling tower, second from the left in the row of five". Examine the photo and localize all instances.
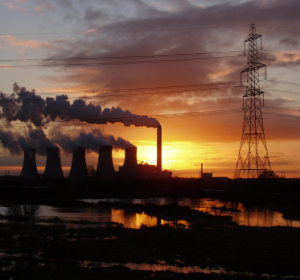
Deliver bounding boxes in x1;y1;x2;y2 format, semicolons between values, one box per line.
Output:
44;147;64;179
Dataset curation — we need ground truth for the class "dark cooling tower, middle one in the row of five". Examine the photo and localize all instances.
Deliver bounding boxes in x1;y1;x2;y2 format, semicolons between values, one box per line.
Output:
69;146;88;181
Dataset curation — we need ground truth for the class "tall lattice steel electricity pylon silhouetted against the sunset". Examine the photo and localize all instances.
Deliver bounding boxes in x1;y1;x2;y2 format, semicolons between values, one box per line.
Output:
234;24;271;178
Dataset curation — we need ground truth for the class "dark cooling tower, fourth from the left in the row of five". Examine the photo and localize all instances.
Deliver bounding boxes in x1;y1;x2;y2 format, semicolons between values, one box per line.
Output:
96;145;115;178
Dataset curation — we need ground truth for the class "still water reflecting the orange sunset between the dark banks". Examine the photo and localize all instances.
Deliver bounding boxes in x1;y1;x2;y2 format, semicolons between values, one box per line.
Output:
0;198;300;229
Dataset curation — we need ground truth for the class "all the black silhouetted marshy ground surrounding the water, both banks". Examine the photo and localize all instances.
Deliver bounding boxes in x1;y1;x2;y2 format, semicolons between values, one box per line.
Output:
0;178;300;280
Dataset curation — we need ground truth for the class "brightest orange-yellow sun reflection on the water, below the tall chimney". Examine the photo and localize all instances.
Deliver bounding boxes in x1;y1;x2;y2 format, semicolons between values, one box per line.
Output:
111;209;157;229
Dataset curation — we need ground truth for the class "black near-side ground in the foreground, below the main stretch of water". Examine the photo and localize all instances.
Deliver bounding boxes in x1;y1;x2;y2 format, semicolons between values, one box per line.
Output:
0;217;300;279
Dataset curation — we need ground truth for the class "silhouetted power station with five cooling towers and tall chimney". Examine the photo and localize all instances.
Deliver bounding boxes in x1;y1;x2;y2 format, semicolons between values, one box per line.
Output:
17;126;162;182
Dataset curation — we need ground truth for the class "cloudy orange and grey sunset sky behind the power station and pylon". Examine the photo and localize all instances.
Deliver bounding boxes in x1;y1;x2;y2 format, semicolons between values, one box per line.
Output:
0;0;300;177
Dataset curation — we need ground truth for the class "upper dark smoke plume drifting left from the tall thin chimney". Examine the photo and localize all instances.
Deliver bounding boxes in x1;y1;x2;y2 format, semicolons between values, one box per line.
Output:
0;83;160;127
